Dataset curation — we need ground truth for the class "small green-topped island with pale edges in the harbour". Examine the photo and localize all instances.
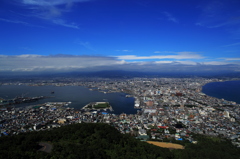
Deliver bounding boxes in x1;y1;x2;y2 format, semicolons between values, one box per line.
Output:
82;102;113;111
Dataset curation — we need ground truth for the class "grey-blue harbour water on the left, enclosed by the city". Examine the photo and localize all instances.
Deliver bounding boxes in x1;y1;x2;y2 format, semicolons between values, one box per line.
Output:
0;85;137;114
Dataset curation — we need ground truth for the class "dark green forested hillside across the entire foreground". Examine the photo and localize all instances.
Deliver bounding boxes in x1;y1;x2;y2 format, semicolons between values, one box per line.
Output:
0;123;240;159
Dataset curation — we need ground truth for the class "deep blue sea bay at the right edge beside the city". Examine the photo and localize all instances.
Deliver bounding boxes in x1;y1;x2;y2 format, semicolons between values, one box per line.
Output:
202;81;240;104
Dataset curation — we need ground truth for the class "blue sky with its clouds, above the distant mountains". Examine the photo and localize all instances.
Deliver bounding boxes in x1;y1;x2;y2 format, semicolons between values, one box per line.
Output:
0;0;240;72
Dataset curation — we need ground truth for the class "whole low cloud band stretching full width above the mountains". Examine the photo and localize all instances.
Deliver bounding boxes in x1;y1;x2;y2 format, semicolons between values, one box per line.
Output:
0;54;240;72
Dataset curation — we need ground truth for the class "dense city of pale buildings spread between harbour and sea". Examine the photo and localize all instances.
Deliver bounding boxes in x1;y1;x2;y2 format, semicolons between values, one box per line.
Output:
0;78;240;147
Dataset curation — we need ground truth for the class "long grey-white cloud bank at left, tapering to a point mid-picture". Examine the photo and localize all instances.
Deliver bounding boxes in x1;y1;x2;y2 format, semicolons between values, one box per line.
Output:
0;54;124;71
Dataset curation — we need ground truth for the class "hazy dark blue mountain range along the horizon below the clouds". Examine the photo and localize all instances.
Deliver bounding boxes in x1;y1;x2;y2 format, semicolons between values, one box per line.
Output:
0;70;240;79
